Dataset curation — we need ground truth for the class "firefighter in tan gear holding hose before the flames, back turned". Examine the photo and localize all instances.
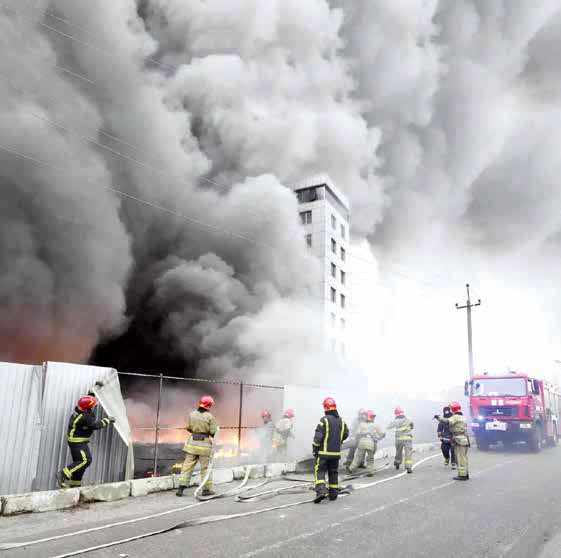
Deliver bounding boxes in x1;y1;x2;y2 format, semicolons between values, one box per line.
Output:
176;395;218;496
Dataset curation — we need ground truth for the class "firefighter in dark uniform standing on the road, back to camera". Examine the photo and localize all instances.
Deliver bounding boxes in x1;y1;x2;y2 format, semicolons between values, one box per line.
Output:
312;397;349;504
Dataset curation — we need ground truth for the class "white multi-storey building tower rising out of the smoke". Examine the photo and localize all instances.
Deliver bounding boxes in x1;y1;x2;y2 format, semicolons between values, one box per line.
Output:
292;175;350;356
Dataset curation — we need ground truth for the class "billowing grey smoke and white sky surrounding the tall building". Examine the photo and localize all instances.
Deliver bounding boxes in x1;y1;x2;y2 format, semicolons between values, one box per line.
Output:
0;0;561;404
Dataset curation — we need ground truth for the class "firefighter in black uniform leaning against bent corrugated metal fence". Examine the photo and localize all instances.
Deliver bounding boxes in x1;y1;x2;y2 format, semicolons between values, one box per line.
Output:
56;395;115;488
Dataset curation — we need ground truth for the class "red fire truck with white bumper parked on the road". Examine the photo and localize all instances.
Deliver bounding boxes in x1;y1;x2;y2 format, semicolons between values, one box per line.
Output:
465;372;561;452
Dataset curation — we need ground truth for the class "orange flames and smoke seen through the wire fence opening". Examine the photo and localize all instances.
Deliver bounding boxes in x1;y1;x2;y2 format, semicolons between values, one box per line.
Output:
119;372;284;476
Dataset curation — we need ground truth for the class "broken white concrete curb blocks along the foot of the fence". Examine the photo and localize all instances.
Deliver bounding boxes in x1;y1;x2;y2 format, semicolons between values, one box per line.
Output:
0;443;439;515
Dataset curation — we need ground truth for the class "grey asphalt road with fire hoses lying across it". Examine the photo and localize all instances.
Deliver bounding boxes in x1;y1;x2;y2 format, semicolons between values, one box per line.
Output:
0;448;561;558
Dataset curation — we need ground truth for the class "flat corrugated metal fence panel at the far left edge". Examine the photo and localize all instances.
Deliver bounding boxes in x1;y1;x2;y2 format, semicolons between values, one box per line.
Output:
0;362;43;494
